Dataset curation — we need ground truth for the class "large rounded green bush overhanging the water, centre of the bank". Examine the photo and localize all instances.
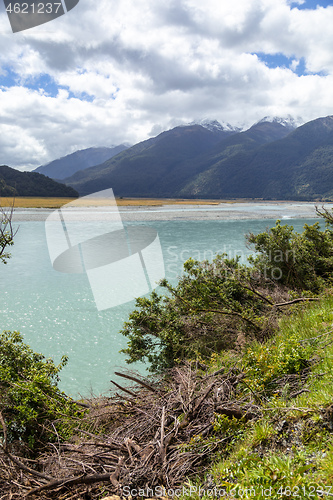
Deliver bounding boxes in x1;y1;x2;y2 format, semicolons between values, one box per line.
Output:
121;256;270;371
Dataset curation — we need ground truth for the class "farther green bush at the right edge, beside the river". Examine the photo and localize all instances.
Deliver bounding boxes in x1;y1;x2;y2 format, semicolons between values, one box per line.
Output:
247;221;333;293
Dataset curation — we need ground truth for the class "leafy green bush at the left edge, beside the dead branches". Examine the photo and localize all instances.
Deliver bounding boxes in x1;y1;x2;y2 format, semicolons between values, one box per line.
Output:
0;332;79;449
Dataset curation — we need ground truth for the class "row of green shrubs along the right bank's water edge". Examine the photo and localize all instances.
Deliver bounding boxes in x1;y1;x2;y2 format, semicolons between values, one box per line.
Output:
121;211;333;371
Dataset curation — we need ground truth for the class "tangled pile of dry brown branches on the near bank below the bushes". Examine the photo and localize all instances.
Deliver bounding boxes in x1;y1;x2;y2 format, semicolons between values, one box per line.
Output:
0;354;316;500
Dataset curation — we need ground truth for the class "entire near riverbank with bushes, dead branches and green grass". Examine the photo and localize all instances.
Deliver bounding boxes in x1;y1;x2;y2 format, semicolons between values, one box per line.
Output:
0;205;333;499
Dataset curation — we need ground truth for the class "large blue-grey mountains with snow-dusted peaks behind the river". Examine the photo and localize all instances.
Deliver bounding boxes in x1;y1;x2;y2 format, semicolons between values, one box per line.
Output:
32;116;333;201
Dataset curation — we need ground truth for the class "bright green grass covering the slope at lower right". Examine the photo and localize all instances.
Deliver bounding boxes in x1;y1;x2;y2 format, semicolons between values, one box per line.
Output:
182;293;333;500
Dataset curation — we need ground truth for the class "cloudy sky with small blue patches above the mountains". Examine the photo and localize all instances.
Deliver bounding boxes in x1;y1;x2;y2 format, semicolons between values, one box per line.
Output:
0;0;333;170
